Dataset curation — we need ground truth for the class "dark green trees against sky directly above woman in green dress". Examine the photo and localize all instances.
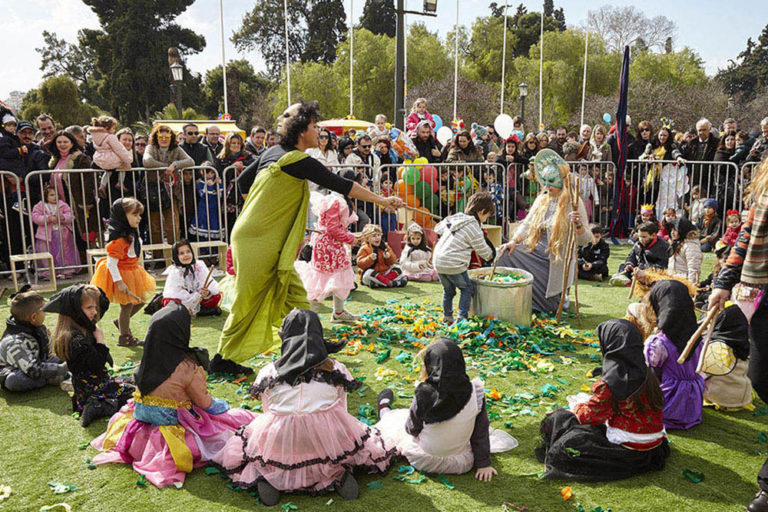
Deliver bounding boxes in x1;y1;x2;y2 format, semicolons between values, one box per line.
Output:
232;0;347;75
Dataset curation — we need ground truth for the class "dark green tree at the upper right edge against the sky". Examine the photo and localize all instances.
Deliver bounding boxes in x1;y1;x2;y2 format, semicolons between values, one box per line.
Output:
716;25;768;99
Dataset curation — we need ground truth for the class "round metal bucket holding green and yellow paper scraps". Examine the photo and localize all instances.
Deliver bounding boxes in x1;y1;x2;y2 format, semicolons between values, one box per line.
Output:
468;267;533;327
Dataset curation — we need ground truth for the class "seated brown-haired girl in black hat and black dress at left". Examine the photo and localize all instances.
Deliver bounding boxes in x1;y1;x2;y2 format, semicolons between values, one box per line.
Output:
43;284;135;427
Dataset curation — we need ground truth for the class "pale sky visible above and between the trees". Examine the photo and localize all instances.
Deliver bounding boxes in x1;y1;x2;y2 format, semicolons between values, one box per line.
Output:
0;0;768;99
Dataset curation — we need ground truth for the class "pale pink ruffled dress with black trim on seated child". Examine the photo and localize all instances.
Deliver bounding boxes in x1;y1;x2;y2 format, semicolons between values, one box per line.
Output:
214;361;395;495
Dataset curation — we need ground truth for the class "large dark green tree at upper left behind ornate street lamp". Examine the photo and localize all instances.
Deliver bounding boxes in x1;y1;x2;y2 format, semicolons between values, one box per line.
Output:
81;0;205;122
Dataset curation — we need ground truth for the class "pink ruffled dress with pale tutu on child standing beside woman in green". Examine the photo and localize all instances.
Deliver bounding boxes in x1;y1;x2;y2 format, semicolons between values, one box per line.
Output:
294;192;357;302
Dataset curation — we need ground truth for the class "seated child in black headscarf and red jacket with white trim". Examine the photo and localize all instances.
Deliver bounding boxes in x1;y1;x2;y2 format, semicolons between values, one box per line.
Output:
536;319;669;481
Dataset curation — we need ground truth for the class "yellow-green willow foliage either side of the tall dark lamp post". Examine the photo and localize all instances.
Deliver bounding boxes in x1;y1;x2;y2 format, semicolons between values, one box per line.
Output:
271;24;453;120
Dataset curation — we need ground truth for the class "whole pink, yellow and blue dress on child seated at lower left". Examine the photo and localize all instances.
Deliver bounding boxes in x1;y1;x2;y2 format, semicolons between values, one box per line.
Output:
91;361;255;487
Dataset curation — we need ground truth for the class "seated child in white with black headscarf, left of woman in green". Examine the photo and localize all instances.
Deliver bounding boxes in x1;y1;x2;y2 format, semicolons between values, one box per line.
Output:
163;240;221;316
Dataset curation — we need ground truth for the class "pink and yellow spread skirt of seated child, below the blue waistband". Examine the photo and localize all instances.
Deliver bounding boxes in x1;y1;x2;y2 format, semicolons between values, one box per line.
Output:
91;400;254;487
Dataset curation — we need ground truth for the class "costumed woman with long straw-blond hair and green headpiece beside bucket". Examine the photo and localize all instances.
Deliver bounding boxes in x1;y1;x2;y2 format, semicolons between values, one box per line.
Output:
498;149;592;312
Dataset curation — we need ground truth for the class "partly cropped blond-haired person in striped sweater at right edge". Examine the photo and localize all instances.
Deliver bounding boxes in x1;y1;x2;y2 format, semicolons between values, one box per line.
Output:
709;161;768;512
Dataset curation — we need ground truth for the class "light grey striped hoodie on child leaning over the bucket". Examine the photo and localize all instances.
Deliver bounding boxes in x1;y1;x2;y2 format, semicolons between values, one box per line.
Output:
434;213;495;275
